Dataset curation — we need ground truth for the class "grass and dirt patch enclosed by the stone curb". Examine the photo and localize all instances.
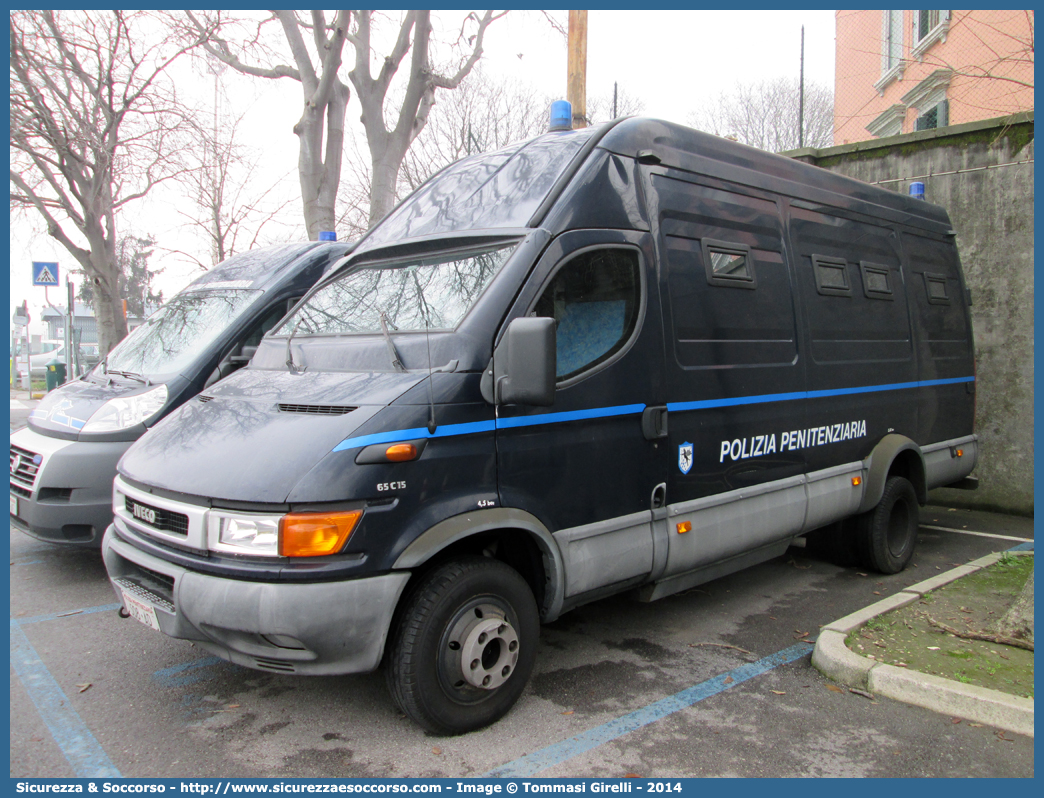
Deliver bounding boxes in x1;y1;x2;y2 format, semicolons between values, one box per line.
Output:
846;554;1034;698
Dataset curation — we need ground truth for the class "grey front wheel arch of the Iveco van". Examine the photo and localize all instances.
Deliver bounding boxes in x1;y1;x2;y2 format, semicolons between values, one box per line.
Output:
392;508;565;623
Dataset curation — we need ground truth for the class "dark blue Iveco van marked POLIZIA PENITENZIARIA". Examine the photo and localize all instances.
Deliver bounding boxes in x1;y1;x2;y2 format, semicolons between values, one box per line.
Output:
103;119;977;733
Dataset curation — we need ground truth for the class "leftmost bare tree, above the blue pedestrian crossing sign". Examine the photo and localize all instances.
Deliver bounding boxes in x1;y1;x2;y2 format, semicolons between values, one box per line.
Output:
9;10;208;353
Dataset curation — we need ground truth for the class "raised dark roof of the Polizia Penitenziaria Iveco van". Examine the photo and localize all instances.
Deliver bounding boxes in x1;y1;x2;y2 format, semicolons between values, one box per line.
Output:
355;118;950;255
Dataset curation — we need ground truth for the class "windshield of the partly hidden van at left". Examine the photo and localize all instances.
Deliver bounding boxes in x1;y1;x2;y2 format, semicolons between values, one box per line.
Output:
105;289;263;376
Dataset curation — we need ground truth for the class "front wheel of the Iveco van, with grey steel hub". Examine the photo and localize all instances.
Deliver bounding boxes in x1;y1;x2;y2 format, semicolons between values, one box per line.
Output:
384;557;540;734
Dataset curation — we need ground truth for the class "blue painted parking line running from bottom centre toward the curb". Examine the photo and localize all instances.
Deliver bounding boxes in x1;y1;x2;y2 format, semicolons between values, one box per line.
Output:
482;642;813;778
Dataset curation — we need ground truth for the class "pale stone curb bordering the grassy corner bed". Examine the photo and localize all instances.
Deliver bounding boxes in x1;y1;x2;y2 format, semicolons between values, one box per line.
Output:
812;551;1034;737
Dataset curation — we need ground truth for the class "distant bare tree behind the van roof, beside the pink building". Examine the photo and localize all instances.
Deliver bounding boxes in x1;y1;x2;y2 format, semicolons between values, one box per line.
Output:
688;77;834;152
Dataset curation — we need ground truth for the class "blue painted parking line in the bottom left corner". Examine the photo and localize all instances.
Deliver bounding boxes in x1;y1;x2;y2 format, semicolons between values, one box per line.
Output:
10;618;122;778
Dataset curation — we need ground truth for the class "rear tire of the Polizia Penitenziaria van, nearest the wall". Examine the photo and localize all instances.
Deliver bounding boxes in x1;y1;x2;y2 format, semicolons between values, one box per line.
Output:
856;476;918;573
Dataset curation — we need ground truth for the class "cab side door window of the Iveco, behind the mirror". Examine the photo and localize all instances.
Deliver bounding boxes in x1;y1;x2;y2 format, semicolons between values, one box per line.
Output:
532;249;642;381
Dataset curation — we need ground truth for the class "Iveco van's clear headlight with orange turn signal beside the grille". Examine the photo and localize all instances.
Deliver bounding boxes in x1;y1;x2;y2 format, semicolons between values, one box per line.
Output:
208;510;362;557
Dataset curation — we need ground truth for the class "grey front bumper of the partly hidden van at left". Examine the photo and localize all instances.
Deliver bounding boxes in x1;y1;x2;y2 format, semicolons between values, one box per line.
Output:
10;427;132;548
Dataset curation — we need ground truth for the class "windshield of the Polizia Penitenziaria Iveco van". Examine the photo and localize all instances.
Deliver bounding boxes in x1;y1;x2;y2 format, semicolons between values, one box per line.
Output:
272;243;515;335
